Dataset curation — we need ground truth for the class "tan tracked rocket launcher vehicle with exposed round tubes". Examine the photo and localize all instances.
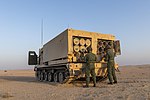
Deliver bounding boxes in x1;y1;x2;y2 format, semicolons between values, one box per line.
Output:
28;29;121;83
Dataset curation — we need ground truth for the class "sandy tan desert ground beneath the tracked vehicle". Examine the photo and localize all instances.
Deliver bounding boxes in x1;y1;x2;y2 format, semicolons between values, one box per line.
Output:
0;65;150;100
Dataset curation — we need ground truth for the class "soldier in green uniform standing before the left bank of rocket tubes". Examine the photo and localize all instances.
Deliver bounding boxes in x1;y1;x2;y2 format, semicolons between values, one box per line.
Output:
85;47;97;87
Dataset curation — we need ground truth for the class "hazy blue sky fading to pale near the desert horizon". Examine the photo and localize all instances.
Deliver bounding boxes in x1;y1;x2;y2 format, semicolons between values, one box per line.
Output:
0;0;150;69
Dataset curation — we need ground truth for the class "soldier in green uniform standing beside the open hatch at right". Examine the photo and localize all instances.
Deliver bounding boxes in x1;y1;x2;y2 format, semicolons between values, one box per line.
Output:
106;43;117;84
